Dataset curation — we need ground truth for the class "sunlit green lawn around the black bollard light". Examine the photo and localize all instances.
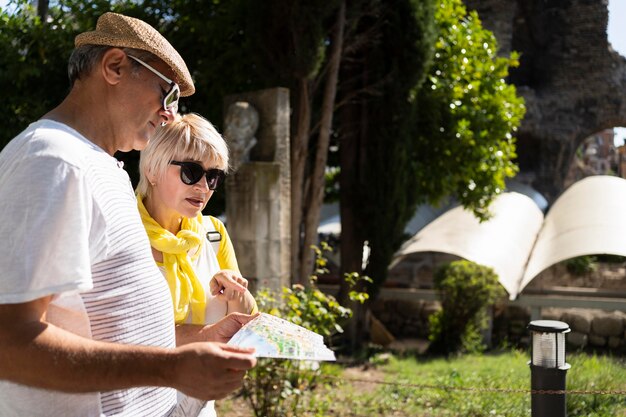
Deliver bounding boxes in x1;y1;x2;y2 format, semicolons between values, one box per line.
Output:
216;350;626;417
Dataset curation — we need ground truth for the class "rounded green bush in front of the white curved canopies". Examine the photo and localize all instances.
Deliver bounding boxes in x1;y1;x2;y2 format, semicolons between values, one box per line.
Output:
429;260;504;354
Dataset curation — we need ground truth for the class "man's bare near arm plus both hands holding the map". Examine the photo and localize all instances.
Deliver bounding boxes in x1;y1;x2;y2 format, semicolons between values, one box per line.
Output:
0;296;256;400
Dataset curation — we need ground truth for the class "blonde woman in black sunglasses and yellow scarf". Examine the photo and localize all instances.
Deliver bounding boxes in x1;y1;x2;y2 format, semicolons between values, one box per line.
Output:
136;114;257;416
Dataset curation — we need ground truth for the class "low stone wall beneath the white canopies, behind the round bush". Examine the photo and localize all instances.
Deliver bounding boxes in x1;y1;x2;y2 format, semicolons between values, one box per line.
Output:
378;252;626;354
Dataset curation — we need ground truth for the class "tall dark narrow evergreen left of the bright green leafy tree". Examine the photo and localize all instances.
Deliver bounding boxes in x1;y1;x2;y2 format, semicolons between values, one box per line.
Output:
340;0;435;294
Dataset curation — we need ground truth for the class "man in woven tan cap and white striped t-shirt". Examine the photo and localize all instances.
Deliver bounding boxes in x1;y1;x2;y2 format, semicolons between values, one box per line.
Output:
0;13;255;416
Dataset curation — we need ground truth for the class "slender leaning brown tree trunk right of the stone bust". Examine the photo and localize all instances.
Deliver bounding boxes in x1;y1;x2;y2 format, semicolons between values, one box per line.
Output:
298;1;346;284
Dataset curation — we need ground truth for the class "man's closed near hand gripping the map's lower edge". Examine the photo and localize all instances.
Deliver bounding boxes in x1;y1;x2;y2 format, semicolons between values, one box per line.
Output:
174;343;256;400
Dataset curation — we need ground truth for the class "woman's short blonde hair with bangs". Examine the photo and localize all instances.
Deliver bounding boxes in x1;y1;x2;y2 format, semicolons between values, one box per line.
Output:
136;113;228;196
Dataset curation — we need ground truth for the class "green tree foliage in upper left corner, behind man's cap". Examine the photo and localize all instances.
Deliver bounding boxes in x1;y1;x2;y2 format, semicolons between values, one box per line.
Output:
0;0;158;148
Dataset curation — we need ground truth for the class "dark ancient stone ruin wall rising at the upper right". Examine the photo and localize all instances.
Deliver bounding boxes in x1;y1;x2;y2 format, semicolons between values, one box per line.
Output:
465;0;626;202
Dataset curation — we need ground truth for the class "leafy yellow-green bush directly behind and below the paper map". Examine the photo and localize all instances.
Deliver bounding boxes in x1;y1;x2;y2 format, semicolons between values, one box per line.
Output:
243;243;369;417
